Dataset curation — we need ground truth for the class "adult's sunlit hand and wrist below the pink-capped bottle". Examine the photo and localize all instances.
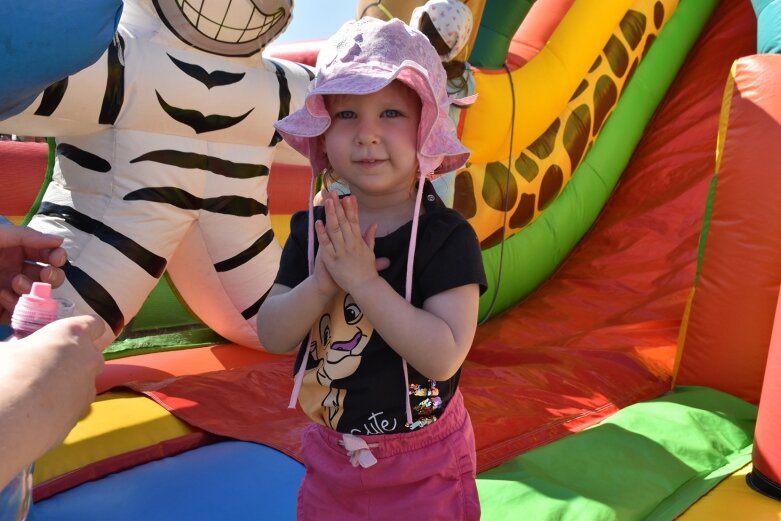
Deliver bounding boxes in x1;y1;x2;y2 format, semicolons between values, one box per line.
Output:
0;316;104;486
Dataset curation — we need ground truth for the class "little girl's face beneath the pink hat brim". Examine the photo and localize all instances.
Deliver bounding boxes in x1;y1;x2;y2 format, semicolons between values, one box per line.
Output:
323;81;421;199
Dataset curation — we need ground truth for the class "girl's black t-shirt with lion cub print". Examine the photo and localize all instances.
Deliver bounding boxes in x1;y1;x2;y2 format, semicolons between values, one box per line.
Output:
275;183;486;435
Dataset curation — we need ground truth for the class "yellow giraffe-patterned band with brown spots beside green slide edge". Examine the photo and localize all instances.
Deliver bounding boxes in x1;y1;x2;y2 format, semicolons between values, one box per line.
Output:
453;0;677;244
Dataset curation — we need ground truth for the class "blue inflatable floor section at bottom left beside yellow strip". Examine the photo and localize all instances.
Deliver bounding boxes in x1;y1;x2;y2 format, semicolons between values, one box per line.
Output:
28;441;304;521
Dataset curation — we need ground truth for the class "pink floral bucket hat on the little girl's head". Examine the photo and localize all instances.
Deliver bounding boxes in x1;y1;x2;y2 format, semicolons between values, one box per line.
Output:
274;17;475;177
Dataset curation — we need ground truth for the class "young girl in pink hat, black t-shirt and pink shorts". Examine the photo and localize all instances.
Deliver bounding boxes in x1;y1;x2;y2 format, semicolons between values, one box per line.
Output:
258;18;485;521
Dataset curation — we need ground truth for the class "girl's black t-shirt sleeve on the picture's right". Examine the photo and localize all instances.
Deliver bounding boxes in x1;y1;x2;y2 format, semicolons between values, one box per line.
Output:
415;213;487;300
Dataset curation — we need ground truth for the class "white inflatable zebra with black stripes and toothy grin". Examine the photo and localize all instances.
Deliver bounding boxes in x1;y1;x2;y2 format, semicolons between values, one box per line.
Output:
0;0;310;346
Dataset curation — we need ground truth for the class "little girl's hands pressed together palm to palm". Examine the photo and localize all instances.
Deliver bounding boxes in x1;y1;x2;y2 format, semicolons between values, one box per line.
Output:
315;193;380;293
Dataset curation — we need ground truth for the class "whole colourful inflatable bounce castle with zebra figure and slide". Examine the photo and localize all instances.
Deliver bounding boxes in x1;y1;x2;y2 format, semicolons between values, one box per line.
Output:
0;0;781;521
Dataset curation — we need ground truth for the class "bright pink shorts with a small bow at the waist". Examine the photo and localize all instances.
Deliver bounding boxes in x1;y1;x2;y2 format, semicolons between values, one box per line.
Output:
298;392;480;521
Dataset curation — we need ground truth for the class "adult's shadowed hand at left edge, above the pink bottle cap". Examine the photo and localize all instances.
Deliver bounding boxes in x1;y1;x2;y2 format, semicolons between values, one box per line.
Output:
0;224;68;323
